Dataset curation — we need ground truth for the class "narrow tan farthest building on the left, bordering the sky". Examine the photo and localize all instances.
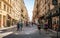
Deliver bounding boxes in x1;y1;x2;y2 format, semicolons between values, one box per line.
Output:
21;0;29;23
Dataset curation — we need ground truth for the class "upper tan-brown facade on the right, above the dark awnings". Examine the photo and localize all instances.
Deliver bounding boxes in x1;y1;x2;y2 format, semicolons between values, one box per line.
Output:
33;0;49;21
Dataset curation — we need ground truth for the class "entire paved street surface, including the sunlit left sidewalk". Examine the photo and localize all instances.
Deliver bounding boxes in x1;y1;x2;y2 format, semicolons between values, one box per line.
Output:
0;26;59;38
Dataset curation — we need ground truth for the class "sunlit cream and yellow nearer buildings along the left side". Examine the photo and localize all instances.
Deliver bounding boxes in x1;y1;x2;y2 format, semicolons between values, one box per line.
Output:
0;0;26;27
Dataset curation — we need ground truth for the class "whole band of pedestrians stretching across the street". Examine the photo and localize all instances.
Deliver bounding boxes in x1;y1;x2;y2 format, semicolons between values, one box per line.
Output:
17;21;48;32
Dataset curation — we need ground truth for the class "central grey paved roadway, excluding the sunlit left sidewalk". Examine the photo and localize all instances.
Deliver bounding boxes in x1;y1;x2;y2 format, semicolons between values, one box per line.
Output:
3;27;51;38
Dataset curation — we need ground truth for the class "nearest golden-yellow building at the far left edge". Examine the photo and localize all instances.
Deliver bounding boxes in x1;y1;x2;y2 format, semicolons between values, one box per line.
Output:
0;0;12;27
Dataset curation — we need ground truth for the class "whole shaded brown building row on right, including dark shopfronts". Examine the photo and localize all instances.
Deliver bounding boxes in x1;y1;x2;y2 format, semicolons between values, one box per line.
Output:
33;0;60;30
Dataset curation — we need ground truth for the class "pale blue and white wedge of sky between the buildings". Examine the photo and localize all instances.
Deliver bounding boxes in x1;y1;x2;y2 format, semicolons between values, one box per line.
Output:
24;0;34;21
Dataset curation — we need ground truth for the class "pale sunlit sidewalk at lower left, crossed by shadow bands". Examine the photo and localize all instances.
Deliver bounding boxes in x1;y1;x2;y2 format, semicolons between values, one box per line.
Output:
0;25;16;38
